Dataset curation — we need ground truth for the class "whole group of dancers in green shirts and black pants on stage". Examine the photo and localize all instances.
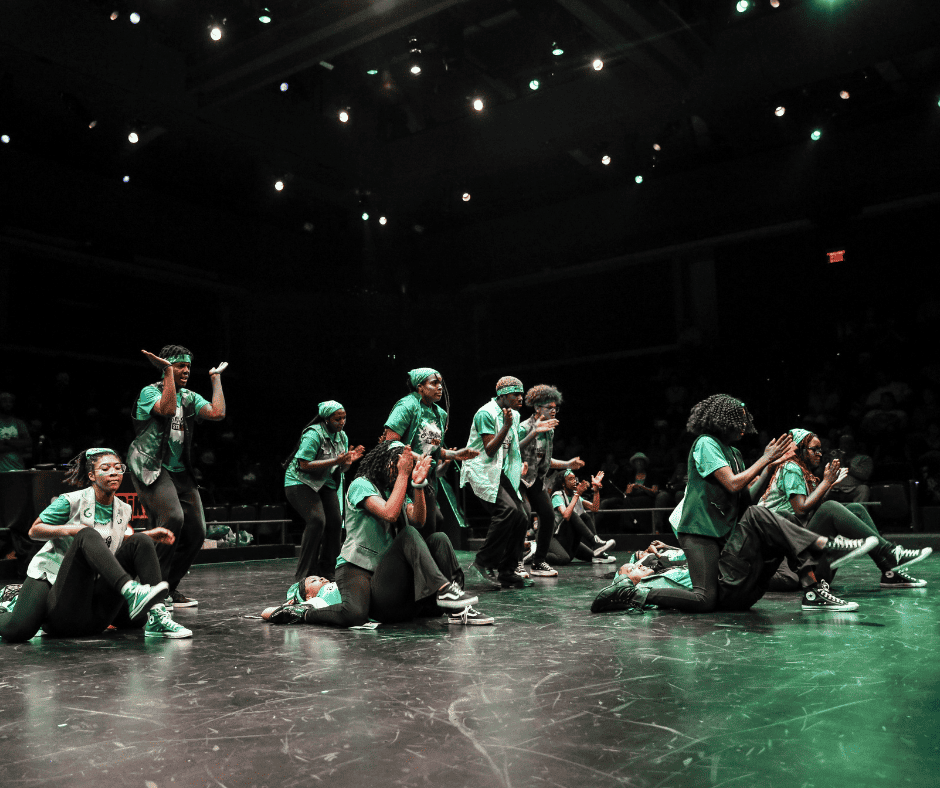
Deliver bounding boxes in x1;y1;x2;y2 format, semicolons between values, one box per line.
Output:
0;352;931;642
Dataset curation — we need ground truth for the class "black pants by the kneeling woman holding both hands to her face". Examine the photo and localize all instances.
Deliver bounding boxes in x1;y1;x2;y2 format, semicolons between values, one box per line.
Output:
304;525;463;627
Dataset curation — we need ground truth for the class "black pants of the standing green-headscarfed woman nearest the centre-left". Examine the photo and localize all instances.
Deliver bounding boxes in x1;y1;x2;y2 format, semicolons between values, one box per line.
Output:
284;484;343;581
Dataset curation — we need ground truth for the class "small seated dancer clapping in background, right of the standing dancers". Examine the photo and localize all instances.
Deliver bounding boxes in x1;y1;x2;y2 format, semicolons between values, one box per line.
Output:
539;471;616;565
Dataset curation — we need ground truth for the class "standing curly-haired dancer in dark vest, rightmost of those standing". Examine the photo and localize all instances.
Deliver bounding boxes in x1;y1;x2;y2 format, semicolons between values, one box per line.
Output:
519;383;584;577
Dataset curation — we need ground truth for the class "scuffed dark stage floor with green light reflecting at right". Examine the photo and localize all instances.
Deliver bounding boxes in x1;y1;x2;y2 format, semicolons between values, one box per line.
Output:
0;553;940;788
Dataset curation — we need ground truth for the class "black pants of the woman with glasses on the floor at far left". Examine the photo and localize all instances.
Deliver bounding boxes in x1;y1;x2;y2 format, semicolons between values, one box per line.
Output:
0;528;160;643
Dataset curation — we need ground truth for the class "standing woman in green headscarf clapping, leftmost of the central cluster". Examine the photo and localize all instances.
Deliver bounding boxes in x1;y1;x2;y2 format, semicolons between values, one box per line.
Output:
284;400;365;580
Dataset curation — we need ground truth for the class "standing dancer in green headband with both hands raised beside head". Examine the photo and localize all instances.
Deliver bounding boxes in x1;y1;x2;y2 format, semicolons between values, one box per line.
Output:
127;345;228;607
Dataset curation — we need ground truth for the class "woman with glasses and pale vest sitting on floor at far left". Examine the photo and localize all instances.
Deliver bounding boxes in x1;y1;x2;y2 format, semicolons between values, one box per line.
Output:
0;448;193;643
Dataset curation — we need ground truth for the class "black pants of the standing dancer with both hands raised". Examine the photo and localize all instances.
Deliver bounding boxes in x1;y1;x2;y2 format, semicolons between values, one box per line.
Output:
131;468;206;591
